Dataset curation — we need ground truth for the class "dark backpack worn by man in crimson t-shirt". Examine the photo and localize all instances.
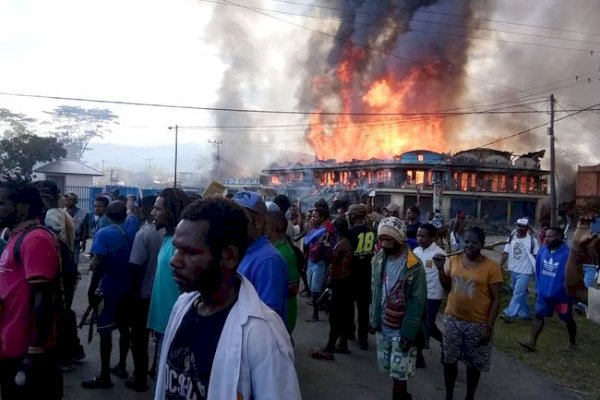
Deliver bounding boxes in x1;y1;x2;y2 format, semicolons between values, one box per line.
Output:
13;224;79;351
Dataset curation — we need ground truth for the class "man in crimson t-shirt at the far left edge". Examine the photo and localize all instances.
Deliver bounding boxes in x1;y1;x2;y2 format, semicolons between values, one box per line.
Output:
0;178;63;400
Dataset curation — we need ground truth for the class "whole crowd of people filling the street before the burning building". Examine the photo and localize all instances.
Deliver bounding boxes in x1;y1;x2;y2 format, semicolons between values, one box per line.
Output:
0;178;591;400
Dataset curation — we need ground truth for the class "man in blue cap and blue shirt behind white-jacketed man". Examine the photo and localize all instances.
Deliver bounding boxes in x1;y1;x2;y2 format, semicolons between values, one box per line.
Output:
233;191;288;321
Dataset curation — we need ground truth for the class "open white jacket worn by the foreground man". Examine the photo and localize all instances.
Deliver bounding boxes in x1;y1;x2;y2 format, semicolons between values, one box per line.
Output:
154;275;302;400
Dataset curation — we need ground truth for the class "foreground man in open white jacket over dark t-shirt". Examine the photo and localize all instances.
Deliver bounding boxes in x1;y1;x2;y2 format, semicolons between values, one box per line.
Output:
154;197;301;400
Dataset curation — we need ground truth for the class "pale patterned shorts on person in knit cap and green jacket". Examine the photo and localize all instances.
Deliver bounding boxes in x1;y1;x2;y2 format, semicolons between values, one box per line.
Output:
375;332;417;381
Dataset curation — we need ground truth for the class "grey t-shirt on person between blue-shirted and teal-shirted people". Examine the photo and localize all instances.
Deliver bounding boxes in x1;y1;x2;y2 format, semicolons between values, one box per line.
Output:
129;222;165;299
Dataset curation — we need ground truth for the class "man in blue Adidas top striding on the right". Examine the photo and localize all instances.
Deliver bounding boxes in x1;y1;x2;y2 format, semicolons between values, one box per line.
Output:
519;227;577;352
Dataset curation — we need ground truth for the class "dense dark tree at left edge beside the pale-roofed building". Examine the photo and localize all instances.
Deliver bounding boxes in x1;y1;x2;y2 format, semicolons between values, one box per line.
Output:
0;133;67;176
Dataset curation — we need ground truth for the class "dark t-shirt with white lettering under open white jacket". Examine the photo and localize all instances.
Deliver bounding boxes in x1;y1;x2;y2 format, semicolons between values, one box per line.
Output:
165;303;235;400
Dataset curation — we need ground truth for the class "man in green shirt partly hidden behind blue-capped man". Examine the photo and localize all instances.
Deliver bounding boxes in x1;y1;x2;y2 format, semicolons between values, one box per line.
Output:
266;203;300;335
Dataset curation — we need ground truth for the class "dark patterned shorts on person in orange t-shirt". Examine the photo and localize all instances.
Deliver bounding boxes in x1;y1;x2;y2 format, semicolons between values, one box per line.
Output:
442;314;492;372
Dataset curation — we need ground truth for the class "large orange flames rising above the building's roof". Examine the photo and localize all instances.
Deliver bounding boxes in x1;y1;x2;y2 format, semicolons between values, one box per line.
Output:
308;45;447;161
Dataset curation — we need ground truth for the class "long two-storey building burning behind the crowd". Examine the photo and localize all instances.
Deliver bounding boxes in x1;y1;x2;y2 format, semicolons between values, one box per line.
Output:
263;148;549;224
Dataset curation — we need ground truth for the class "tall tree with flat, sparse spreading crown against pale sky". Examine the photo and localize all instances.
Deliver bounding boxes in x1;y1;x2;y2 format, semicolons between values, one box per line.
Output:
46;105;119;160
